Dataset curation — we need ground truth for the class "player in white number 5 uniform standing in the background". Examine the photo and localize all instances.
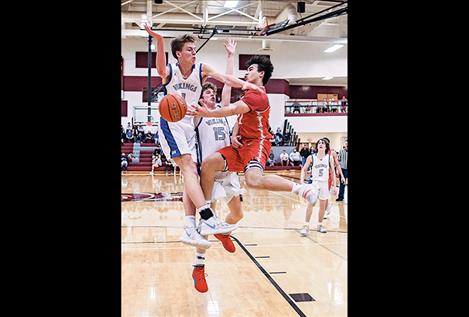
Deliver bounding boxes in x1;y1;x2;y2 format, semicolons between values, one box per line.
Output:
300;139;337;236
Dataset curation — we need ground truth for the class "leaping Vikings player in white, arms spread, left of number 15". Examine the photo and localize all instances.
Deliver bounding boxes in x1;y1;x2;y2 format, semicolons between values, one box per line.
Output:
145;25;258;248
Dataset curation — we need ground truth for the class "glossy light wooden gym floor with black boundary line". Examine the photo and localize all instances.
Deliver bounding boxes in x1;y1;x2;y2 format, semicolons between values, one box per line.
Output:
122;171;347;317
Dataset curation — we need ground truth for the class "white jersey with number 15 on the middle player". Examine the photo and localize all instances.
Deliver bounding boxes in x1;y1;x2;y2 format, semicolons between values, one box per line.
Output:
195;106;231;163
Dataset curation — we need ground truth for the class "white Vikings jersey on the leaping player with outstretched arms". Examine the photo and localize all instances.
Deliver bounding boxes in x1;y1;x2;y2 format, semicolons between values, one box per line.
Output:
164;63;202;125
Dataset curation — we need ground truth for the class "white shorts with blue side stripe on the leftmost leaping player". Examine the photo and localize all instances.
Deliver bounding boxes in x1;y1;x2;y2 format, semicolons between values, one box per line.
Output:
158;118;197;163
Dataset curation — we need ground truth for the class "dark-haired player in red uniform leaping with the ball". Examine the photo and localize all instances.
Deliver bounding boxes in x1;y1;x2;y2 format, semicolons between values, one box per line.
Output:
189;55;318;215
